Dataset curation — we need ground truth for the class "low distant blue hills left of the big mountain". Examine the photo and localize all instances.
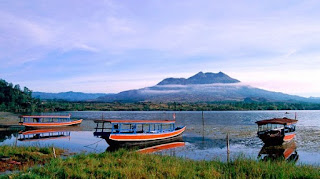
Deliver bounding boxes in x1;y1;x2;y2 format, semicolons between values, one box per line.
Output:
32;91;107;101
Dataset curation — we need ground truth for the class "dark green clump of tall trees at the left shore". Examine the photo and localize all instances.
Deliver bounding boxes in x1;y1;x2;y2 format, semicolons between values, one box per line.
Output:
0;79;41;113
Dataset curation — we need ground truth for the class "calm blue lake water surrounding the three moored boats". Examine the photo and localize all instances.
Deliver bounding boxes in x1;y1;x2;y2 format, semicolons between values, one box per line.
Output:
0;111;320;166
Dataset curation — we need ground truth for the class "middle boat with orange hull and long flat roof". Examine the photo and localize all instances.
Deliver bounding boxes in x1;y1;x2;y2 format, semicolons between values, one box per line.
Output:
93;120;186;147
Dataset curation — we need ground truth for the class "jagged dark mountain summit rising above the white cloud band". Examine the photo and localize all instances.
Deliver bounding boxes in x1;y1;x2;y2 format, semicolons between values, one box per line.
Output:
157;72;240;85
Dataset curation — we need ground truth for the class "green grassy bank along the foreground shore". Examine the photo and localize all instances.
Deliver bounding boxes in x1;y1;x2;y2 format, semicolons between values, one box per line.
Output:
0;147;320;178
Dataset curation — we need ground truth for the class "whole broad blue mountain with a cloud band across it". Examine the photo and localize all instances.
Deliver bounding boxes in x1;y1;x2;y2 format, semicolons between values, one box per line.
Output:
97;72;318;102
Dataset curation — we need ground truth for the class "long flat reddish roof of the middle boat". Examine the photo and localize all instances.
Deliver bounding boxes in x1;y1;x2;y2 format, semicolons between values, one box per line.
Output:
94;119;176;124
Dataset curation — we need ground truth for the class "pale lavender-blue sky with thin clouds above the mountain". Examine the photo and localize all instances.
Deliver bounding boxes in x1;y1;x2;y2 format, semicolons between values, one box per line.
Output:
0;0;320;97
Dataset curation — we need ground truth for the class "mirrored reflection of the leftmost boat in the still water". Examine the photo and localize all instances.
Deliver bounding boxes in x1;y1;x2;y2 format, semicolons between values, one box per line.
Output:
18;129;70;141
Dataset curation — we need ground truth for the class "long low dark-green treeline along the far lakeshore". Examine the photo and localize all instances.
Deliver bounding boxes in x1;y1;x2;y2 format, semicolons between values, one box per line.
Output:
36;101;320;111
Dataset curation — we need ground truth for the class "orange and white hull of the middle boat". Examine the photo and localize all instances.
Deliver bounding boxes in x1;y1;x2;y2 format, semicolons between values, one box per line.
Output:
100;127;186;147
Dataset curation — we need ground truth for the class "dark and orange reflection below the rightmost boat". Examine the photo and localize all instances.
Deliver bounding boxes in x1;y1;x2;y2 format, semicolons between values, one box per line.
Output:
258;140;299;162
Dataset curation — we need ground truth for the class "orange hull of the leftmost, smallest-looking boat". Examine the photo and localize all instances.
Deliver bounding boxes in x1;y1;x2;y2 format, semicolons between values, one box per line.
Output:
19;119;82;128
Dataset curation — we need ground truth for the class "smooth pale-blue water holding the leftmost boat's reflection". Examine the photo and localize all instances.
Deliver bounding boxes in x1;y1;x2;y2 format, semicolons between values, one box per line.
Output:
0;128;108;153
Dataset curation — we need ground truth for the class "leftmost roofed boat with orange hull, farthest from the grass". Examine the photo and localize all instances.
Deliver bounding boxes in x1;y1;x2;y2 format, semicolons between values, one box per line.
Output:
19;115;82;128
